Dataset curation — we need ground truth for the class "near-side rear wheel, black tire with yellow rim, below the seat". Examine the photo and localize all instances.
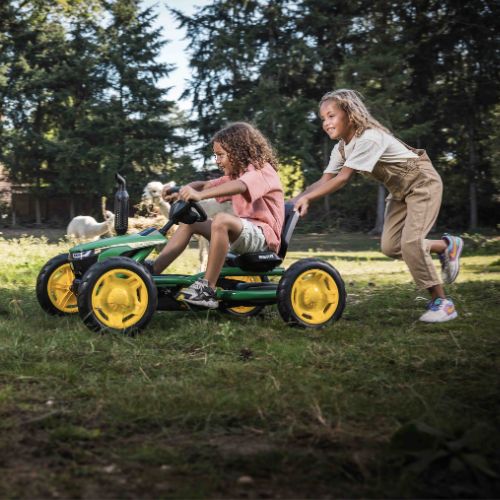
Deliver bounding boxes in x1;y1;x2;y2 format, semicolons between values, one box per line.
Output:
278;259;346;328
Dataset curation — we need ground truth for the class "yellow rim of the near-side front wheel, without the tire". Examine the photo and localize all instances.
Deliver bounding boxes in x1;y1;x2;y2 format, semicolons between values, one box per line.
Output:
92;269;149;330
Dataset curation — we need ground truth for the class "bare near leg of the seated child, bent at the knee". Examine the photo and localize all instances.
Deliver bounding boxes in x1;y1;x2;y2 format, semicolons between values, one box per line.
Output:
205;213;243;288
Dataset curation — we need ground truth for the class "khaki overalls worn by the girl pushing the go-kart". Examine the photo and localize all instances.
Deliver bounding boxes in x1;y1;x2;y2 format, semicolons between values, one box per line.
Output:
339;141;443;288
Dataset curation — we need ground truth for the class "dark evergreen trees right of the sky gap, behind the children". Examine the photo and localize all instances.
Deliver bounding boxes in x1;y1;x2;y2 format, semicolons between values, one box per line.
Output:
174;0;500;228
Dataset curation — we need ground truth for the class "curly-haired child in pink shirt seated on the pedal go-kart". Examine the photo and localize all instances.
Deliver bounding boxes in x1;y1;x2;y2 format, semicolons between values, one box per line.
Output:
152;122;285;309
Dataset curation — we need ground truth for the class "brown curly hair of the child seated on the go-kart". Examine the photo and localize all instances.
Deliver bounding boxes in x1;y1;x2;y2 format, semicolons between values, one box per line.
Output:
212;122;278;178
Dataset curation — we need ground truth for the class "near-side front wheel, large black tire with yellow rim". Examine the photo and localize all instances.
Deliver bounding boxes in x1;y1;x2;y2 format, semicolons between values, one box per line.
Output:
78;257;158;334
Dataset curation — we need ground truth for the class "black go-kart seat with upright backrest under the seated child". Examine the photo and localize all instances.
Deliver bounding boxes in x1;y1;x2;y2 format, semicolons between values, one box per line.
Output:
225;203;299;272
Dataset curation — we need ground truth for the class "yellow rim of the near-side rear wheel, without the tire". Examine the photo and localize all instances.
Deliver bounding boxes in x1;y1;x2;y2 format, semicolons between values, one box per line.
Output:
291;269;339;325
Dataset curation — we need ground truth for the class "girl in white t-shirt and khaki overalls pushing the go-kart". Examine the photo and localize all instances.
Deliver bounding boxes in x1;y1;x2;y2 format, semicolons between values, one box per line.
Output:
293;89;463;323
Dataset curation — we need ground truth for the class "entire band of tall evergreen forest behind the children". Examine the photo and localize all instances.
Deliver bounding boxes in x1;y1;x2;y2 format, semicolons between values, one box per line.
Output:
0;0;500;230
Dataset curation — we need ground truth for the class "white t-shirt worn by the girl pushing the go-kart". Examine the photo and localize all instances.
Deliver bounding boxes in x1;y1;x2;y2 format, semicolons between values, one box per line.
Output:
323;128;418;174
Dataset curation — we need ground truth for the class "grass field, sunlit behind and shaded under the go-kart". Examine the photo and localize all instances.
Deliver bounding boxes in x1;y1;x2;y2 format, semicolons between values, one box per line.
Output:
0;231;500;498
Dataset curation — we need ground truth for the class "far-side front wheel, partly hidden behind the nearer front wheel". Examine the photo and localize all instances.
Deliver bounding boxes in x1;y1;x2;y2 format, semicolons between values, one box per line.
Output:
36;253;78;316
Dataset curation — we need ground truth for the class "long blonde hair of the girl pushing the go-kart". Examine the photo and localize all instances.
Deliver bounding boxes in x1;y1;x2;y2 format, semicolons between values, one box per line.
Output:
319;89;392;137
